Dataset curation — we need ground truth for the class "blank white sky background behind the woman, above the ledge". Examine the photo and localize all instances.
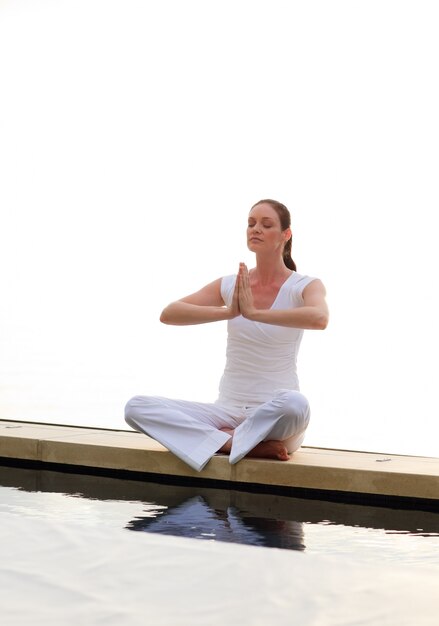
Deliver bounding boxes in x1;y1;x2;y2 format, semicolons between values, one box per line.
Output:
0;0;439;456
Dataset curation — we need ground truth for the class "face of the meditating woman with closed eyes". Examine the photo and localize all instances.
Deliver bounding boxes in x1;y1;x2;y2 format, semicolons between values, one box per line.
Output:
247;202;291;255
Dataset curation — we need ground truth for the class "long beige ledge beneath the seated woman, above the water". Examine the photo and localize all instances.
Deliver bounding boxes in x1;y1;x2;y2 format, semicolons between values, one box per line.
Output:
0;420;439;509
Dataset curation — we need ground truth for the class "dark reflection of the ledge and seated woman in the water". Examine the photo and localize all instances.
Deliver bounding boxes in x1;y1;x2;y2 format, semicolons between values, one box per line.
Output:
0;466;439;550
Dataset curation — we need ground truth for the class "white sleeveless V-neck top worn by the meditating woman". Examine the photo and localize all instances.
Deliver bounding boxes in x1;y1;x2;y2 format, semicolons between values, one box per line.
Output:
216;272;315;407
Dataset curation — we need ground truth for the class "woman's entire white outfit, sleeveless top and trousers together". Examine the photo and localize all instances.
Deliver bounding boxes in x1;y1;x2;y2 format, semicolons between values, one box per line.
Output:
125;272;314;471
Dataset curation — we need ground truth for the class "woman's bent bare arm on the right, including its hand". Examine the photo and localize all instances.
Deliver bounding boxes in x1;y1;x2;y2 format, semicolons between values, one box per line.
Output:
239;270;329;330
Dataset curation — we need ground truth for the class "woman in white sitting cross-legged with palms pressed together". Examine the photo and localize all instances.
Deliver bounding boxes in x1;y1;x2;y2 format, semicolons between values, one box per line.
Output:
125;200;328;471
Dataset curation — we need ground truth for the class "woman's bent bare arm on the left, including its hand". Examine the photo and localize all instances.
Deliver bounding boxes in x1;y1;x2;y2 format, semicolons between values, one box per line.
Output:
160;278;239;326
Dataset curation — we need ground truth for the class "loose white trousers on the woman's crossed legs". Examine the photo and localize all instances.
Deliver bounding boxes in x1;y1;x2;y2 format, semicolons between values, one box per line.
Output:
125;389;310;471
